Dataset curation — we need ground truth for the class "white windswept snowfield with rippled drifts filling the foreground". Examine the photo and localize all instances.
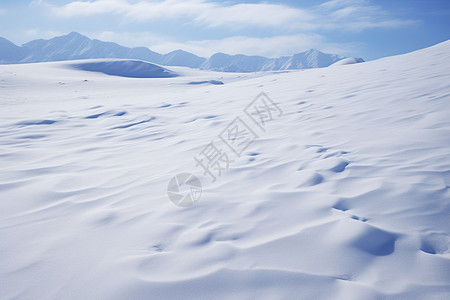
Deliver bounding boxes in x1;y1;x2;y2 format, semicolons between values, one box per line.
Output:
0;41;450;300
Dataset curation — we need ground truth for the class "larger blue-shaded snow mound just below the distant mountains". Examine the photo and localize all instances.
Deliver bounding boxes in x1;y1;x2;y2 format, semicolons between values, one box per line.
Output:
69;60;178;78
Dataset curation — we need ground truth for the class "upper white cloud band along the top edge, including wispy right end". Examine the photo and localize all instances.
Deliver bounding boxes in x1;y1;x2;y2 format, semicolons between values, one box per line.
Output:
39;0;413;32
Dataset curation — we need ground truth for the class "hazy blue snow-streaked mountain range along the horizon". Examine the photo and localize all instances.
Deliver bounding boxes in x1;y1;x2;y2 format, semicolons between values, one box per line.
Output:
0;32;364;72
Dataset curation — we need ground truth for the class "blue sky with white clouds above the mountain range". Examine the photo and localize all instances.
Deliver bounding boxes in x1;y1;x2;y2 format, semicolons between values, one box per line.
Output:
0;0;450;60
